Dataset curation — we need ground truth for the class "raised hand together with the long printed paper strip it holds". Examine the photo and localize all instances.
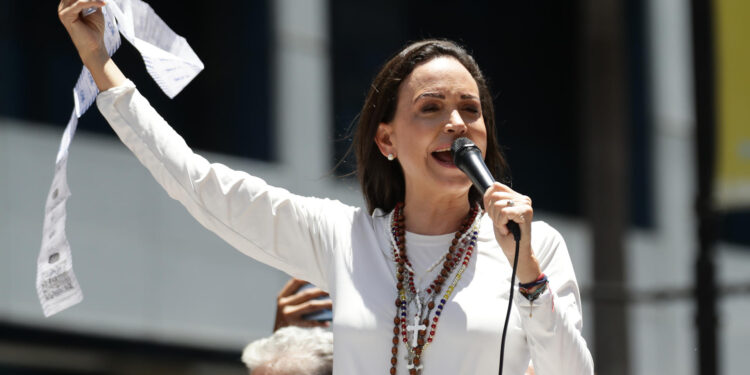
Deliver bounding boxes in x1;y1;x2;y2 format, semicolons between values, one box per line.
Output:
36;0;203;316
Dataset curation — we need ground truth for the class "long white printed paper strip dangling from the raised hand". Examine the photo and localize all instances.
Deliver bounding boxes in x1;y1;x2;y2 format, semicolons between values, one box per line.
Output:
36;0;203;317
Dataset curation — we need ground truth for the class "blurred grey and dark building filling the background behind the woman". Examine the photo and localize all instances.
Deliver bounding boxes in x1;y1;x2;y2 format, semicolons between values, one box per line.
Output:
0;0;750;374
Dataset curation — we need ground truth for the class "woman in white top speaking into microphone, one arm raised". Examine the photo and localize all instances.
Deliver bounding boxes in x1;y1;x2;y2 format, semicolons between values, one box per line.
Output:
58;0;593;375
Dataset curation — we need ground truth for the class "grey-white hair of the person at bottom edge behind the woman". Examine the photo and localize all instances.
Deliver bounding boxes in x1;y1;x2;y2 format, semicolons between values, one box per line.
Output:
242;326;333;375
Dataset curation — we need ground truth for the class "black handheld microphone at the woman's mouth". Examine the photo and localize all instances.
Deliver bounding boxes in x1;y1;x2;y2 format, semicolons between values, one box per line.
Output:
451;137;521;242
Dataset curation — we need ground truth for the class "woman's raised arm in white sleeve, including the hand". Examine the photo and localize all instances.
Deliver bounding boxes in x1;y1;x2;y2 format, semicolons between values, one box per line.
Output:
58;0;356;289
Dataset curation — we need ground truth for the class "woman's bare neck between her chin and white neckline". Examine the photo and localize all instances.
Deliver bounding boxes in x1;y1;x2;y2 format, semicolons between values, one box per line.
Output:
404;189;471;235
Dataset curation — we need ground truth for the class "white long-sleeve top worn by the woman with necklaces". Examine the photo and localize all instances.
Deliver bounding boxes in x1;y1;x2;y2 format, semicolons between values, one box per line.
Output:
97;81;593;375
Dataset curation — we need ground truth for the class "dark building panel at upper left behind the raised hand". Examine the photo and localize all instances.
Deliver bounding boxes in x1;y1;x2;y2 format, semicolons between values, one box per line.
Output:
0;0;274;160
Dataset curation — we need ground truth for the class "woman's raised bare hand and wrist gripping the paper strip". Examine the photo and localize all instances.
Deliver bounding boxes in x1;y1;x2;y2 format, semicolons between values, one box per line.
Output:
57;0;126;91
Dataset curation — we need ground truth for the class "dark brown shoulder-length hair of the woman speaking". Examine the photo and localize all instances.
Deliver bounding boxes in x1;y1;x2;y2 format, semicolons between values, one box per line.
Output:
352;40;508;214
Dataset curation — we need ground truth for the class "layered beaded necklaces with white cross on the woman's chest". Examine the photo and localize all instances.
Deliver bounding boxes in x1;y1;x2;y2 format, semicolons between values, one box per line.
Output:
390;202;480;375
